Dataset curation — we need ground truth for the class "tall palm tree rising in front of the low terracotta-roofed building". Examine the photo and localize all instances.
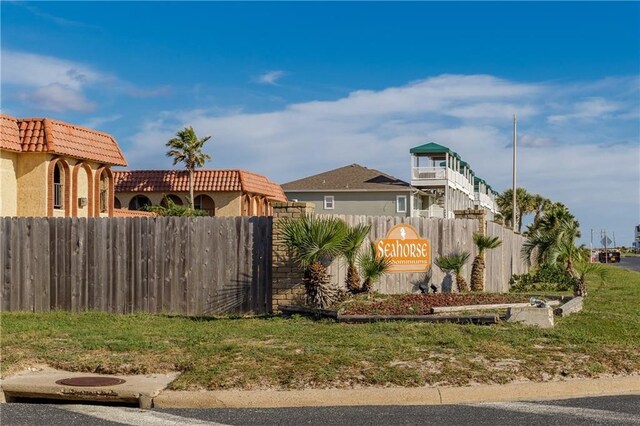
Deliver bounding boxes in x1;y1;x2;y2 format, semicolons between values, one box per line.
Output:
166;126;211;209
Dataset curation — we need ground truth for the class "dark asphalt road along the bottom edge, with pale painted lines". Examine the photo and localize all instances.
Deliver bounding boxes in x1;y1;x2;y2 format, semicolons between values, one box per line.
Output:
0;395;640;426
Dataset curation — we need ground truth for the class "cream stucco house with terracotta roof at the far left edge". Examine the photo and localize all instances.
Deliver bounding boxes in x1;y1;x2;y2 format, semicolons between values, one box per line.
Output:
0;114;127;217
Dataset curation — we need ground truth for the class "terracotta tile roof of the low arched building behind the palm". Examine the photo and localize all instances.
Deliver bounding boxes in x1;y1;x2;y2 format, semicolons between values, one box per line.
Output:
113;170;287;201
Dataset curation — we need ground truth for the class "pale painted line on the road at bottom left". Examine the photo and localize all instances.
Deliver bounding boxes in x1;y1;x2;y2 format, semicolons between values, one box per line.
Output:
56;405;229;426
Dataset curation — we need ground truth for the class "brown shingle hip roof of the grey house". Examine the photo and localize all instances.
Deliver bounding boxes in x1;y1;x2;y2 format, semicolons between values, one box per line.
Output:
282;164;410;192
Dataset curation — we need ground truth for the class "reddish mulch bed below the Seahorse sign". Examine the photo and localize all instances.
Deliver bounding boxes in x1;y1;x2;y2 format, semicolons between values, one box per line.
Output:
339;293;529;315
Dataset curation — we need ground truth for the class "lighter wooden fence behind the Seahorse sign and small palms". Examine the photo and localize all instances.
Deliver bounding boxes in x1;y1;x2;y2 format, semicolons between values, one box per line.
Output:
320;215;528;293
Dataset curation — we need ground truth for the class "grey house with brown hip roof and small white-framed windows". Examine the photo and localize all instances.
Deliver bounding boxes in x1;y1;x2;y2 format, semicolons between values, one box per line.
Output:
282;164;416;217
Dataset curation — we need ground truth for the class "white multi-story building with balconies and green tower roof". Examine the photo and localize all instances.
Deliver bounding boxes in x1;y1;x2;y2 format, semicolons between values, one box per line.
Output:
410;143;498;220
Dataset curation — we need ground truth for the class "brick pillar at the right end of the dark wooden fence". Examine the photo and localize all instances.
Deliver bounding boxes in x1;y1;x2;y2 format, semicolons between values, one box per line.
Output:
271;202;315;311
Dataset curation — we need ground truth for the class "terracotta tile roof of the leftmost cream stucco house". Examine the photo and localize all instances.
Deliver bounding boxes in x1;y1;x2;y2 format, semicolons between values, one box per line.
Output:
0;114;127;166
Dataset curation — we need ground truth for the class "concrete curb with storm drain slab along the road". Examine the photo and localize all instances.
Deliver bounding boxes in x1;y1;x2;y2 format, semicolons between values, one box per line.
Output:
0;368;640;408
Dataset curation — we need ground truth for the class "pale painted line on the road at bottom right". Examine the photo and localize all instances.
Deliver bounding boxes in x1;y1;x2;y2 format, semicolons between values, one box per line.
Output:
465;402;640;424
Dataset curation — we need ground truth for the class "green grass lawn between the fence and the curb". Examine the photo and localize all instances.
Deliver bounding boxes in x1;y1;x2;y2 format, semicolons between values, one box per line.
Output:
1;266;640;389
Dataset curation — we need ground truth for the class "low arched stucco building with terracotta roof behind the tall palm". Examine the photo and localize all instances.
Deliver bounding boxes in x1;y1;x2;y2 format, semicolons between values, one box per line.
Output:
114;170;287;216
